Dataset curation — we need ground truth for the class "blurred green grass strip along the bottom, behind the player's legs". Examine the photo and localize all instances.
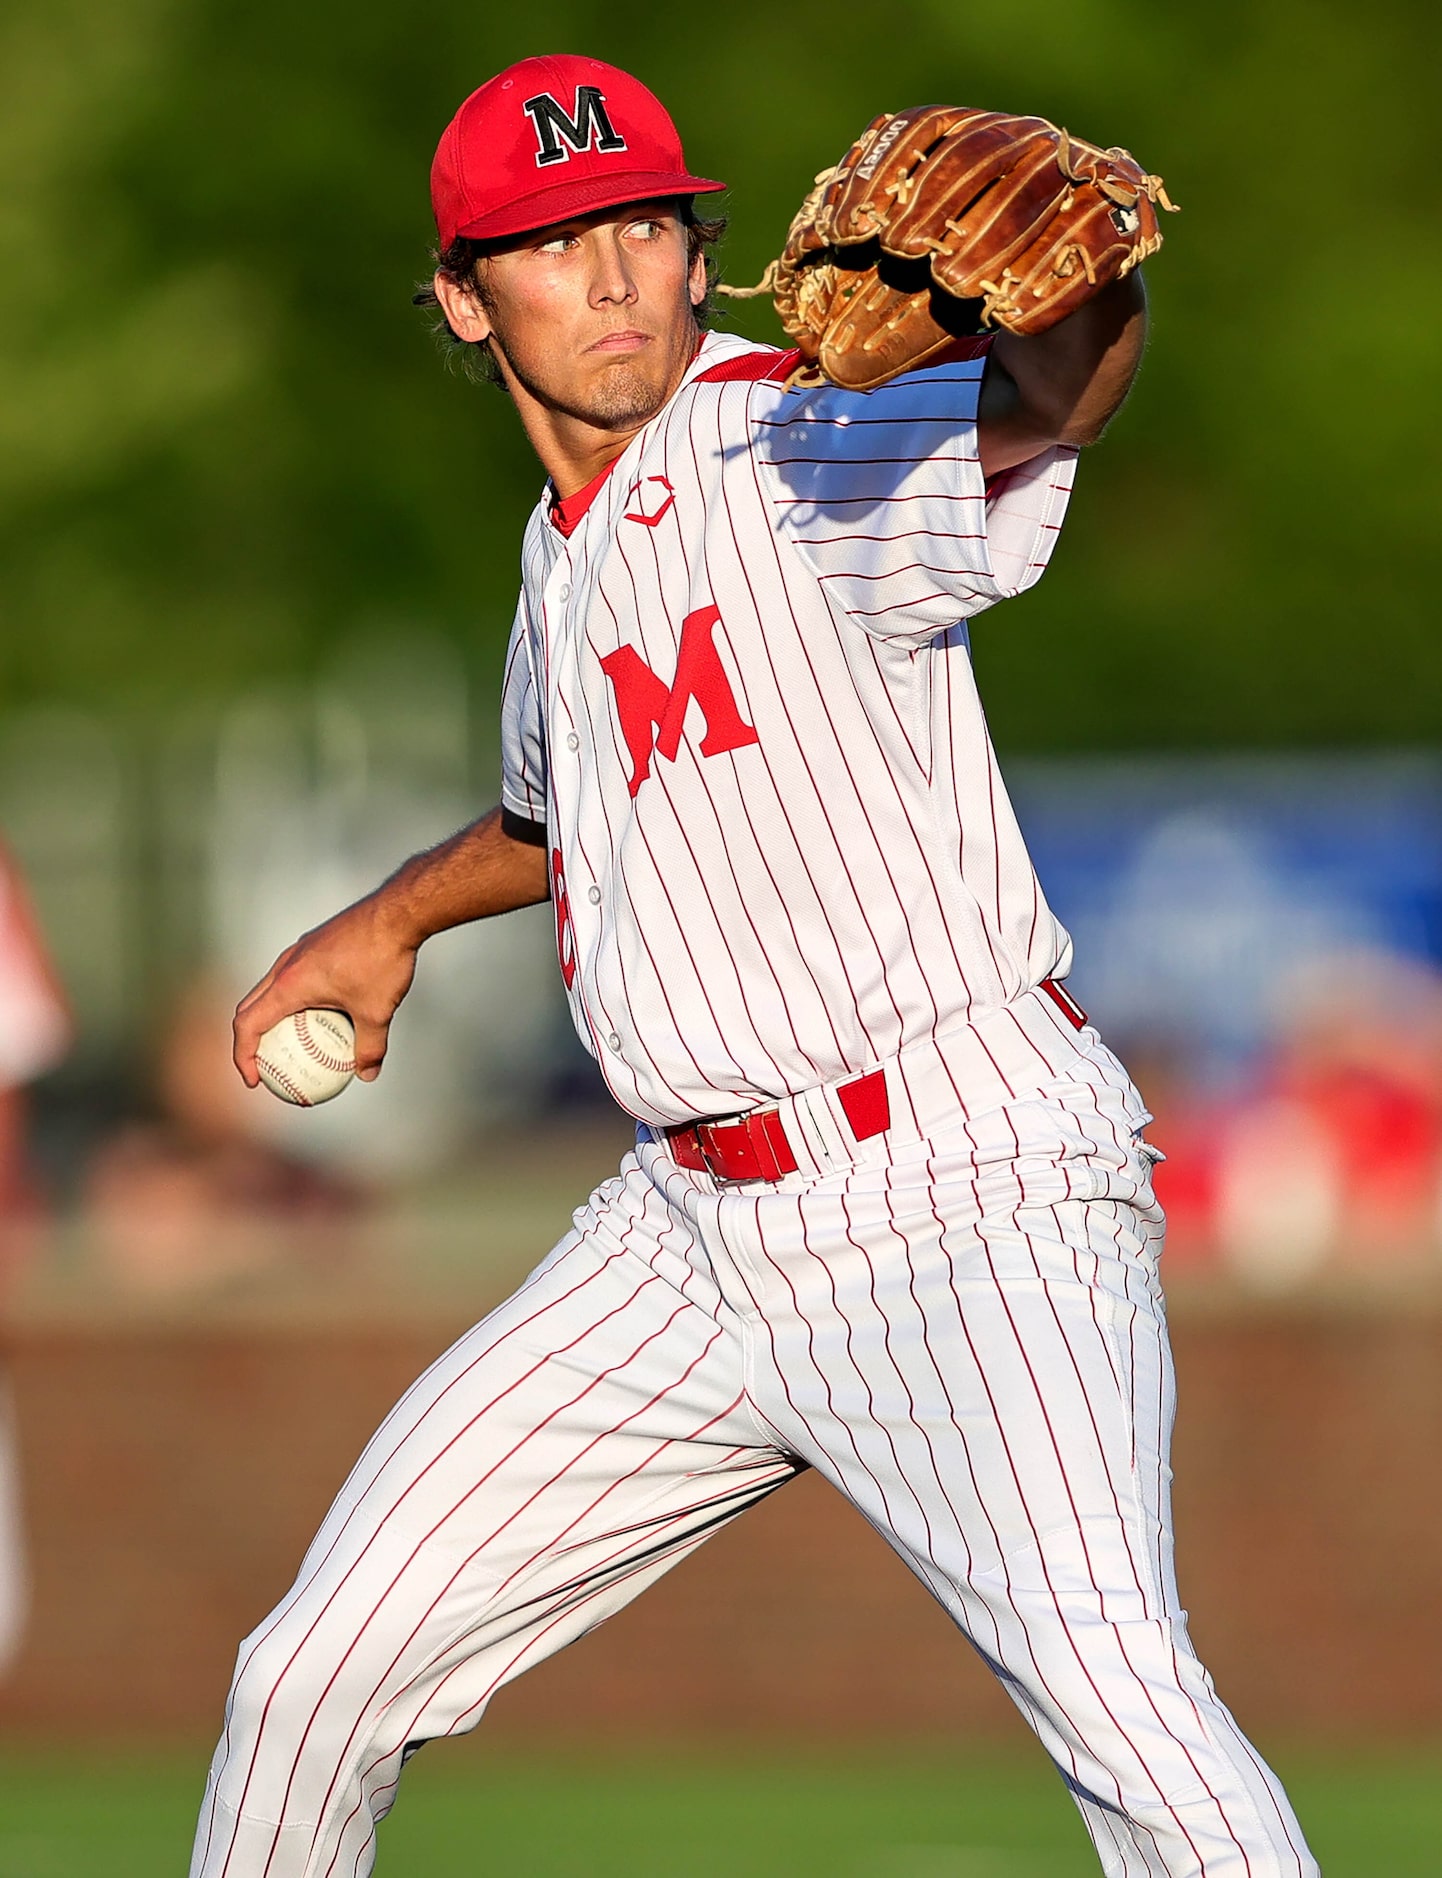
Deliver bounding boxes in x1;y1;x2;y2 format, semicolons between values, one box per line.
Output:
0;1742;1442;1878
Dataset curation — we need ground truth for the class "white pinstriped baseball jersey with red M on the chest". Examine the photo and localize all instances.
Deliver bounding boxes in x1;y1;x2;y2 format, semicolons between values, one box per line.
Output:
501;334;1076;1125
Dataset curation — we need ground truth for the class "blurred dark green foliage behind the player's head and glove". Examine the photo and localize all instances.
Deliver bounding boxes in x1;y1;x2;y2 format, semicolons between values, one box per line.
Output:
0;0;1442;749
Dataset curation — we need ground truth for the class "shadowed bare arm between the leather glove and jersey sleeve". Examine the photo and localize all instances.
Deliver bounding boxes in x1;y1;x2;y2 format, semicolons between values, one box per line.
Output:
980;270;1147;473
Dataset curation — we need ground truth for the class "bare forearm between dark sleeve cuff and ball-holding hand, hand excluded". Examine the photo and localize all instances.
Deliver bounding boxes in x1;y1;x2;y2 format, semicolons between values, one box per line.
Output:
372;808;550;947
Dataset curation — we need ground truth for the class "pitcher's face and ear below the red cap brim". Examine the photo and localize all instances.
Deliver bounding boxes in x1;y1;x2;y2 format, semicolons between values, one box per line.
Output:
437;201;706;430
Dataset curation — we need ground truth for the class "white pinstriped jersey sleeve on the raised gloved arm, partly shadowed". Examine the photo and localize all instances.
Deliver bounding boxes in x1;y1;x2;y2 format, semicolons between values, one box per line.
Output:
753;359;1076;644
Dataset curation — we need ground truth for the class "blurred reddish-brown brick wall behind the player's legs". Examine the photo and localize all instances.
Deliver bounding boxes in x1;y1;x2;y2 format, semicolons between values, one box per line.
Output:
0;1307;1442;1743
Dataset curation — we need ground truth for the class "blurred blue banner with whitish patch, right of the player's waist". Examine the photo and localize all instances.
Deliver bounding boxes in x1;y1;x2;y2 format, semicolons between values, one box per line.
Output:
1008;755;1442;1085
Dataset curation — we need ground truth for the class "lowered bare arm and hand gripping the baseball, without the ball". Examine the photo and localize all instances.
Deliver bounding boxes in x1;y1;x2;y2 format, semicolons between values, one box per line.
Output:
235;808;548;1089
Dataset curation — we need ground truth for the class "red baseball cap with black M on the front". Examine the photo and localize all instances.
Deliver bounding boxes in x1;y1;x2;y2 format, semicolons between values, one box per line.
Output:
430;53;725;248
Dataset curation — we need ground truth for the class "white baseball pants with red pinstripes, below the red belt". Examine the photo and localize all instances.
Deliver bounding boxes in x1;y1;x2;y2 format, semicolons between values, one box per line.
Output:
192;1048;1318;1878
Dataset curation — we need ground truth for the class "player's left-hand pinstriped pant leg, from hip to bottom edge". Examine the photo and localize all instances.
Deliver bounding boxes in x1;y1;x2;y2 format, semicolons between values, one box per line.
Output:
195;1166;796;1870
